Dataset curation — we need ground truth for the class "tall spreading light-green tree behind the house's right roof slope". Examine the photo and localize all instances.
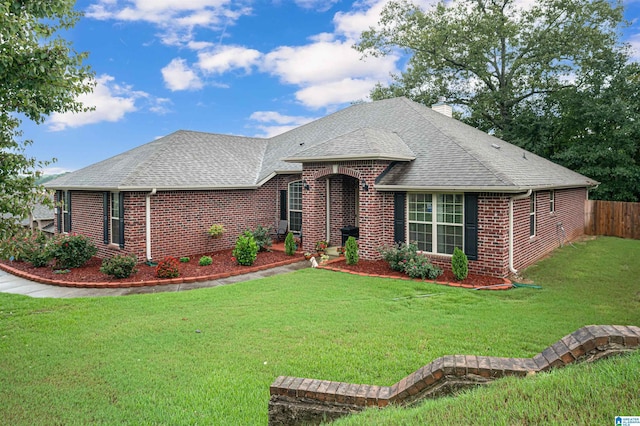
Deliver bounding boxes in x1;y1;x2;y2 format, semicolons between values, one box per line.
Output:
355;0;624;137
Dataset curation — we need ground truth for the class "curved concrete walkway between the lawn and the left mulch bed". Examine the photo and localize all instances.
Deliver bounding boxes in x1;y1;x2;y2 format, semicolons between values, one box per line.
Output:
0;262;309;298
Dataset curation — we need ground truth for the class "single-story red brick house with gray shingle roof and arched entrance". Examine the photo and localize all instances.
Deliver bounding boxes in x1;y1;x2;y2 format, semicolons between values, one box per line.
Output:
46;98;597;276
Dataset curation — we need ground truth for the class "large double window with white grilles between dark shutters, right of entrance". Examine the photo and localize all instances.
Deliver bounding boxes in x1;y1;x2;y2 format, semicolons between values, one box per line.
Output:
408;194;464;254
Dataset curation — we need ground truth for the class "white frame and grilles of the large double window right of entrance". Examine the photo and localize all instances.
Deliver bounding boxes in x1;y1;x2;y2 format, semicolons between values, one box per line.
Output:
406;192;464;256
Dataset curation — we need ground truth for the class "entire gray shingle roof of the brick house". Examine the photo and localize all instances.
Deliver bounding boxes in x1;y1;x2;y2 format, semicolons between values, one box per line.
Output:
47;98;597;192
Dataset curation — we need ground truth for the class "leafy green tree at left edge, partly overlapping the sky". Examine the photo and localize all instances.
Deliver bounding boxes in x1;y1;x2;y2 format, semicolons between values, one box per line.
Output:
0;0;94;238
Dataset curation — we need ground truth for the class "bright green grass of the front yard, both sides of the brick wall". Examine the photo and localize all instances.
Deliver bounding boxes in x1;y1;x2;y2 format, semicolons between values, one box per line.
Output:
0;238;640;425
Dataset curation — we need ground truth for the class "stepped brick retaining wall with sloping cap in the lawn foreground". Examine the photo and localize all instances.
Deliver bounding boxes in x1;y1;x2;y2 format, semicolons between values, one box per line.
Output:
269;325;640;425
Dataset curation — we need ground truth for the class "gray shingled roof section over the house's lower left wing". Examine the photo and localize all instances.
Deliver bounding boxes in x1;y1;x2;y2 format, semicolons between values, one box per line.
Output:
46;130;267;191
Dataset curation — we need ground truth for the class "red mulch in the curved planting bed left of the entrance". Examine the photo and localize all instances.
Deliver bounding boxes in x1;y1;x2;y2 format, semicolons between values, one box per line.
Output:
0;250;301;283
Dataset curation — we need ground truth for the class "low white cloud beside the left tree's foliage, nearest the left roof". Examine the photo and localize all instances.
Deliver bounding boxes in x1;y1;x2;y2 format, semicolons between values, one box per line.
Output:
47;74;141;132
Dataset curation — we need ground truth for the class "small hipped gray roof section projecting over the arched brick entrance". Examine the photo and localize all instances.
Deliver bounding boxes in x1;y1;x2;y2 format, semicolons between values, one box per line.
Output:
283;127;416;163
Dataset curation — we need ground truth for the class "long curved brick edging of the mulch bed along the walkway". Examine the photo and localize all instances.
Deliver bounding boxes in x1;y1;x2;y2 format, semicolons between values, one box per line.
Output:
0;256;304;288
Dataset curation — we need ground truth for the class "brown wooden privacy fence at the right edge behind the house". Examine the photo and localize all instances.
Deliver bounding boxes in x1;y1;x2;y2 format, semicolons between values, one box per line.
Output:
584;200;640;240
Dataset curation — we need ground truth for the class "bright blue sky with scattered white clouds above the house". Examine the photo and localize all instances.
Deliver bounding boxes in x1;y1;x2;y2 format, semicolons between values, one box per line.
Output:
23;0;640;173
